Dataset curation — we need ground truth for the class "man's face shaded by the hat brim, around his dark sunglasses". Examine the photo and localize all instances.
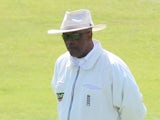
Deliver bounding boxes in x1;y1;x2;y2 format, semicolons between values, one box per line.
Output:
63;28;94;58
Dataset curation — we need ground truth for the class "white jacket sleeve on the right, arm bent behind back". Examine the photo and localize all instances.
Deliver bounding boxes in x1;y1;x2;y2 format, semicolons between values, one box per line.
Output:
112;58;146;120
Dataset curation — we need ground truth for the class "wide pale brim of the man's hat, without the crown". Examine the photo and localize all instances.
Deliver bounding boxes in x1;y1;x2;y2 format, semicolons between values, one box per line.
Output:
48;24;106;34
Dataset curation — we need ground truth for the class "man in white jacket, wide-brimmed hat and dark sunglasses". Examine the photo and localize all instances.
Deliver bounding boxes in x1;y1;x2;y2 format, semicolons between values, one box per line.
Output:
48;9;146;120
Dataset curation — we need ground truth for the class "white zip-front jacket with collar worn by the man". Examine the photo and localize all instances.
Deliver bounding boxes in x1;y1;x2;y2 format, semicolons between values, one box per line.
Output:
52;39;146;120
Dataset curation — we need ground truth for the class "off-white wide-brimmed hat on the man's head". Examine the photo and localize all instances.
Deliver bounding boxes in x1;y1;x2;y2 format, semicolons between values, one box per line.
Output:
48;9;106;34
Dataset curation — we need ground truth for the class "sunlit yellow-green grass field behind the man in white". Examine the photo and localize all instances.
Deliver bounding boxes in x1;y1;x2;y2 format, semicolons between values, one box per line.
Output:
0;0;160;120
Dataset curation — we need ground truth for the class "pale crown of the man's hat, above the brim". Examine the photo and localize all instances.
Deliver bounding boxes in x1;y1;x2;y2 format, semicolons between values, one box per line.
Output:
60;9;94;30
